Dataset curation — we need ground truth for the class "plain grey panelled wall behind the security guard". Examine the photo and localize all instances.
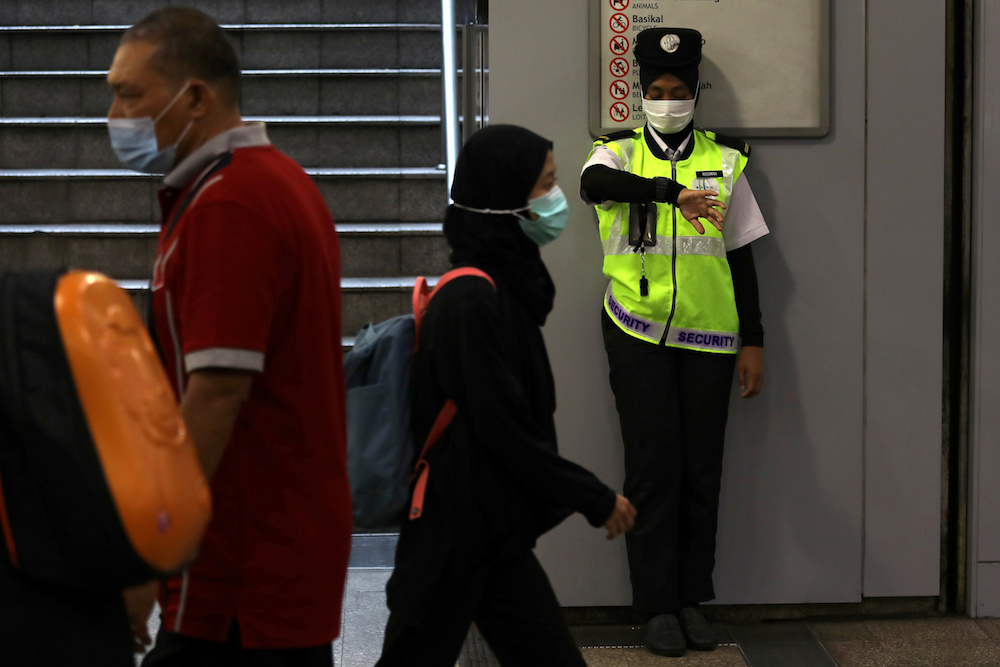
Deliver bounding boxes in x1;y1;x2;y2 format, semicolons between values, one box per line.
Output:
490;0;944;606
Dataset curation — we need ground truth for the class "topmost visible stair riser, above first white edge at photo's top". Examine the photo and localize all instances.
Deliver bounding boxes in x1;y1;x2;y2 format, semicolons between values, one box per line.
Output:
0;0;441;25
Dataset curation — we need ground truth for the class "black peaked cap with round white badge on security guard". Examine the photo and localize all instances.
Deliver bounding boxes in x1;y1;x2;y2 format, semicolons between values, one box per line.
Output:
633;28;702;95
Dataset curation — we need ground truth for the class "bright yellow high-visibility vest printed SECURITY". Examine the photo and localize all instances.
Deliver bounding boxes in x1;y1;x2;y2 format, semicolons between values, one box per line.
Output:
594;128;750;353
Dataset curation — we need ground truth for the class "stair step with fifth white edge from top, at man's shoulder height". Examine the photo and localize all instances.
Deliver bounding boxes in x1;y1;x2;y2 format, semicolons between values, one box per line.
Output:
0;223;449;279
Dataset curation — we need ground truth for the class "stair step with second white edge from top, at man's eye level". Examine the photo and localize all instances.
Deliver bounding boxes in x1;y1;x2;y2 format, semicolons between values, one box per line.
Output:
0;68;450;117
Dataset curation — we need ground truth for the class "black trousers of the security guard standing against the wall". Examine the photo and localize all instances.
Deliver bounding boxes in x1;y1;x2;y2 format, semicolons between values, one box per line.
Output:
602;311;736;614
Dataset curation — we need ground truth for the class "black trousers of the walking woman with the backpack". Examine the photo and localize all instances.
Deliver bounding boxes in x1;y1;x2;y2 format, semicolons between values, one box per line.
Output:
376;543;586;667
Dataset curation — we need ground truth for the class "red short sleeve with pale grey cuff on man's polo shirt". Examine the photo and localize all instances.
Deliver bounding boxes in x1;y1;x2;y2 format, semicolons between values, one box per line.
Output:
177;201;291;373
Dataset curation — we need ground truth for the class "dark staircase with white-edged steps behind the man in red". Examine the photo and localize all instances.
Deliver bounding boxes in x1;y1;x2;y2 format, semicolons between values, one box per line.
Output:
0;0;448;345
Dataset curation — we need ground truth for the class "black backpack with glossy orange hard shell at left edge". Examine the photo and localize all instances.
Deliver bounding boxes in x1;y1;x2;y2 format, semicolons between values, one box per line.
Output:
0;271;211;590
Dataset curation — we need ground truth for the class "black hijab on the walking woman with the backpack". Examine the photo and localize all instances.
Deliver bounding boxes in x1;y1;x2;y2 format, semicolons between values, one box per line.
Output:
444;125;555;326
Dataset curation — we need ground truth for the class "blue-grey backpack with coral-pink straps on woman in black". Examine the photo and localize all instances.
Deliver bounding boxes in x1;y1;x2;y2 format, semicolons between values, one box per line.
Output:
344;268;496;529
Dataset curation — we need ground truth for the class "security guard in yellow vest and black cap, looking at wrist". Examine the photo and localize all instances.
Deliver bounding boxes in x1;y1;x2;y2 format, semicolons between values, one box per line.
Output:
580;28;768;656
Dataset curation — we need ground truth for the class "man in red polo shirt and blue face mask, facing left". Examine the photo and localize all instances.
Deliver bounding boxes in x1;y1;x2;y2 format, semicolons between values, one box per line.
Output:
108;8;351;667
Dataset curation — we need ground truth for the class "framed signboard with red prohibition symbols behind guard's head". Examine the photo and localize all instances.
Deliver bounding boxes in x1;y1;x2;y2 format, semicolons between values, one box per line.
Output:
590;0;830;137
